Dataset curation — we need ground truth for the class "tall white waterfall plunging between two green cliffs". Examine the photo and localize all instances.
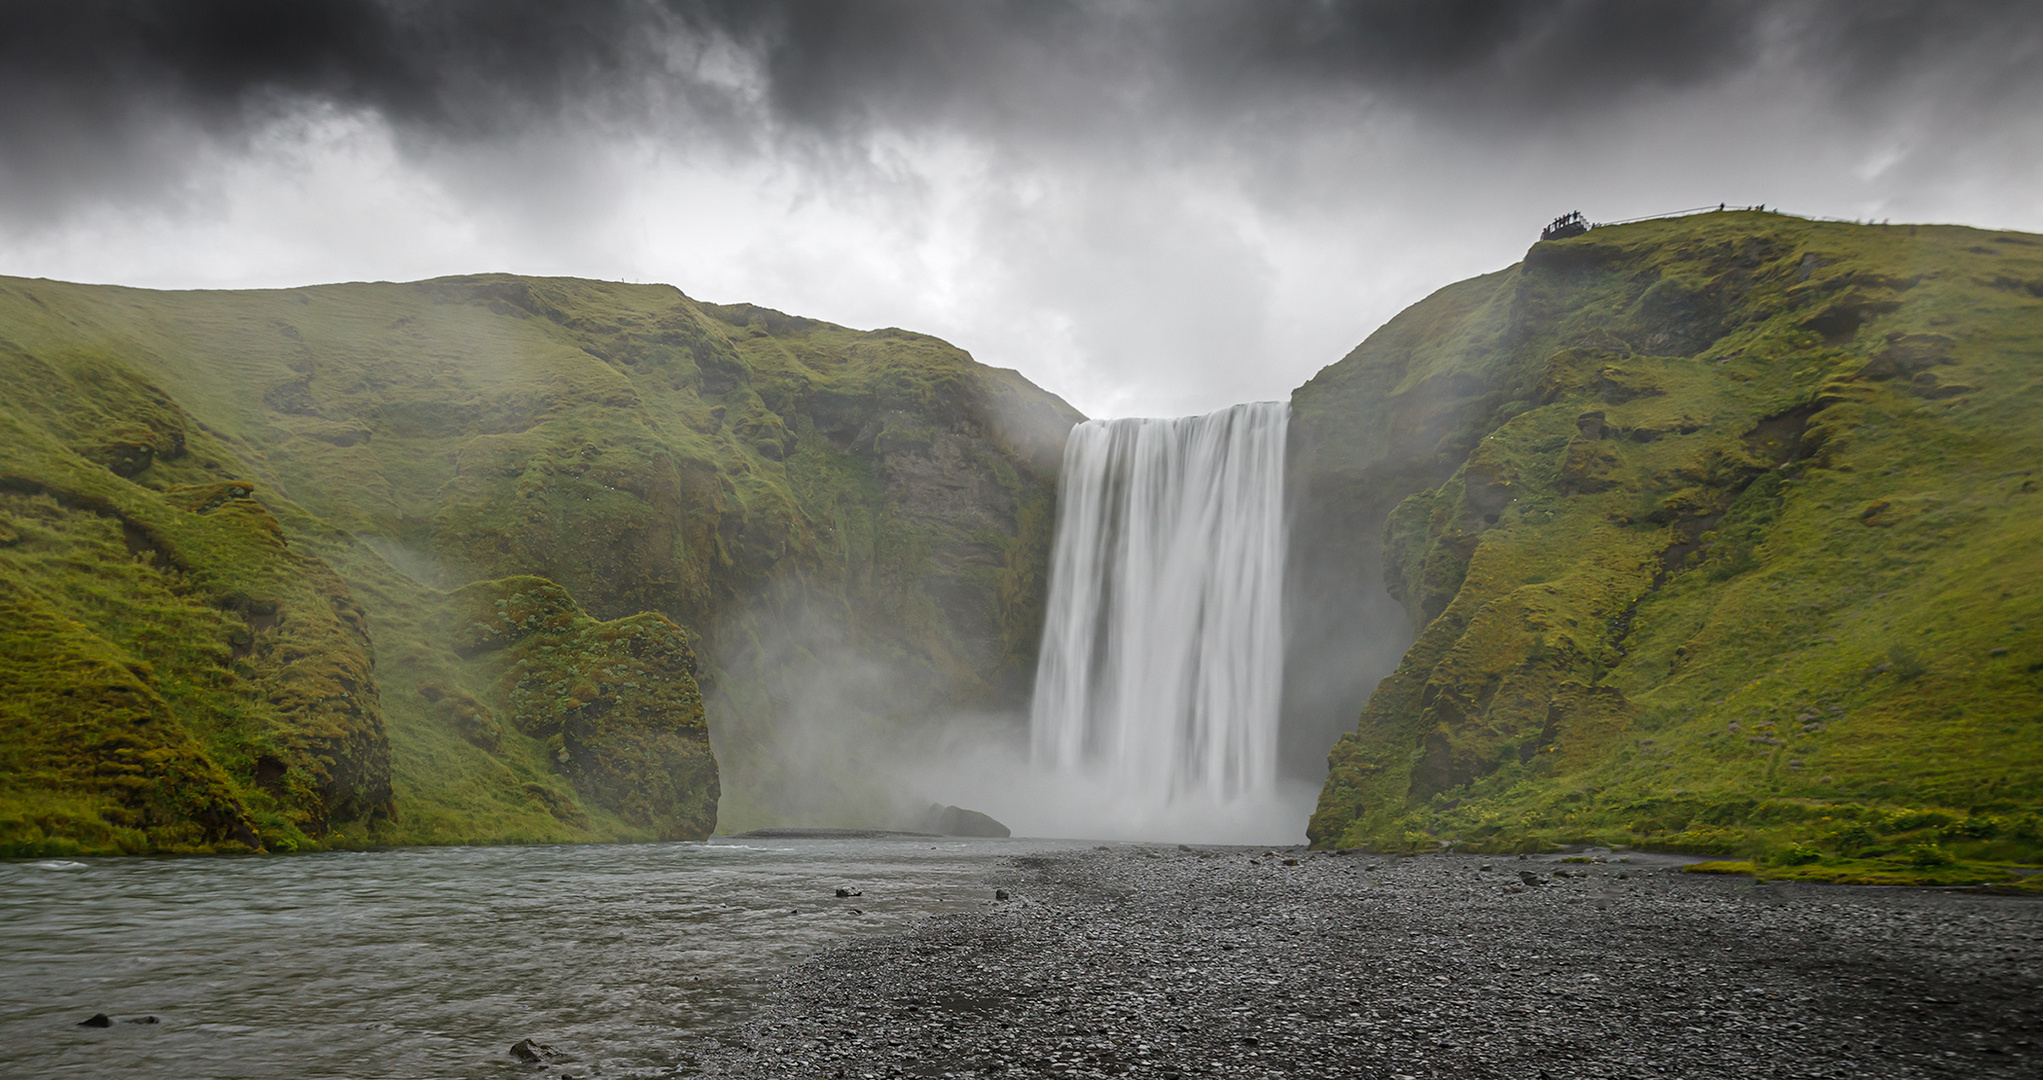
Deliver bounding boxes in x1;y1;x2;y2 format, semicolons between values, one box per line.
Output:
1030;402;1289;806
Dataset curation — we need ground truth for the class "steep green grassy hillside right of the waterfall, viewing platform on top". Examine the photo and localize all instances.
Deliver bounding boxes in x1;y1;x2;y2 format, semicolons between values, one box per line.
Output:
1295;212;2043;878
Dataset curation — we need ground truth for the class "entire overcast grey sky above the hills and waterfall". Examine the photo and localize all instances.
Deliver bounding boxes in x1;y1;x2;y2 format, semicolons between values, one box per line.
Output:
0;0;2043;416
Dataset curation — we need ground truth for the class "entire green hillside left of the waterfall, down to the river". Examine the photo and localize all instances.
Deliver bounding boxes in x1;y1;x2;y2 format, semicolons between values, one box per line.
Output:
0;276;1077;853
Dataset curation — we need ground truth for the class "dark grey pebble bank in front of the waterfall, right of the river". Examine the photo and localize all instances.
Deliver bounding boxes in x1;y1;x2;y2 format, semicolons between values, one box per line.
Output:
701;847;2043;1080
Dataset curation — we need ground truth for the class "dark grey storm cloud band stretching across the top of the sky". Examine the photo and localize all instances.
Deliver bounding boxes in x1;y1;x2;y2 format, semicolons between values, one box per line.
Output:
0;0;2043;216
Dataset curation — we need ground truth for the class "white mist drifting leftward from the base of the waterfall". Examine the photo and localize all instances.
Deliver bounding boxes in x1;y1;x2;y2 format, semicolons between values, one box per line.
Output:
701;563;1323;843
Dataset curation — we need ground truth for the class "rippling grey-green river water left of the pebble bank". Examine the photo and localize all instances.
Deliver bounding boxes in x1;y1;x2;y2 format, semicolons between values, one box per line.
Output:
0;839;1044;1080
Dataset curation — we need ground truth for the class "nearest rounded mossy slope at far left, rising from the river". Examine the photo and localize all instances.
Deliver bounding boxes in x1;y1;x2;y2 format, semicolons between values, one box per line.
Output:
0;349;390;853
